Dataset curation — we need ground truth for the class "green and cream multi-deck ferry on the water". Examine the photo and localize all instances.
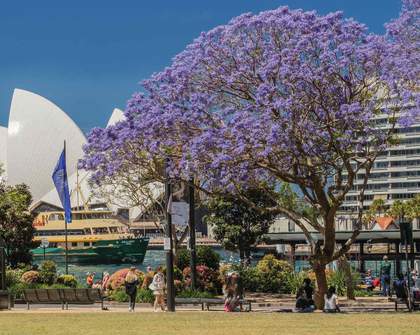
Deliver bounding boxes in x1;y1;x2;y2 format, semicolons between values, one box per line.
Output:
32;210;149;264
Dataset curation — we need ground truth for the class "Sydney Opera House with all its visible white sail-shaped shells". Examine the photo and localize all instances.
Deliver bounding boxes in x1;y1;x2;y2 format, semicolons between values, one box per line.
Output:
0;89;128;215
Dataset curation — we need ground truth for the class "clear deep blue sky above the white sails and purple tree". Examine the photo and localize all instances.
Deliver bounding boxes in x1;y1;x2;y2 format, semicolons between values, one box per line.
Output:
0;0;400;132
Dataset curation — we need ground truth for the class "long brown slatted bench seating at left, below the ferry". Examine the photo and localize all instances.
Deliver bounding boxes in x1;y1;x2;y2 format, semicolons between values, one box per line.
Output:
23;288;104;309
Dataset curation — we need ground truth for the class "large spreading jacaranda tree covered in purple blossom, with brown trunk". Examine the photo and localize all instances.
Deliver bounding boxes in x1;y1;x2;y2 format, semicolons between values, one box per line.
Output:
81;7;418;304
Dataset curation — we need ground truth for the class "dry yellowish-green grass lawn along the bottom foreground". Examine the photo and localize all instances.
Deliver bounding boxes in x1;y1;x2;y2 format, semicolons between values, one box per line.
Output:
0;312;420;335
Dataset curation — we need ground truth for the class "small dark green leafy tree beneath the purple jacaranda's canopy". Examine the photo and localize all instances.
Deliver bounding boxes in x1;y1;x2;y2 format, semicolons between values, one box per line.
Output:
205;188;275;265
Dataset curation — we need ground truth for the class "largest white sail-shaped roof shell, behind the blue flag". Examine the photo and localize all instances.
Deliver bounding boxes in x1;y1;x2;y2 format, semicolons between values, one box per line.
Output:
7;89;86;201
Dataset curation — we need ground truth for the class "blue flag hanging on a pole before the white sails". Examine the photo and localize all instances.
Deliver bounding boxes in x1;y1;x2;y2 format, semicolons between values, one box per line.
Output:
52;149;71;223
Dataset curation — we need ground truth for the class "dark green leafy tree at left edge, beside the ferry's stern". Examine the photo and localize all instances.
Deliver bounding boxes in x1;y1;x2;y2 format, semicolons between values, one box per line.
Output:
0;182;35;268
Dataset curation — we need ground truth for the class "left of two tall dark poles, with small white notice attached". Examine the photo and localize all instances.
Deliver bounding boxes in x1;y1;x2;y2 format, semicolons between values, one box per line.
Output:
164;161;175;312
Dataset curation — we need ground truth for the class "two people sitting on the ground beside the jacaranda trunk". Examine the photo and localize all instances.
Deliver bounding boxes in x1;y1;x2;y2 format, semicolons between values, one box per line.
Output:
295;278;340;313
